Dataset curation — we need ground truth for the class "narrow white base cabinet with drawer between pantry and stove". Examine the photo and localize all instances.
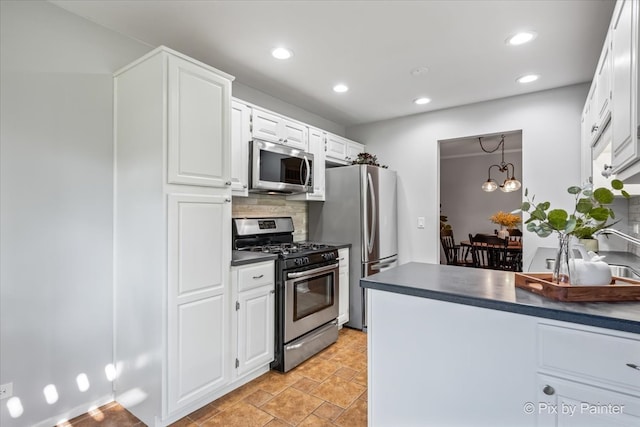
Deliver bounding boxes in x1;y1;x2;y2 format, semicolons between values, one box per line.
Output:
231;261;275;378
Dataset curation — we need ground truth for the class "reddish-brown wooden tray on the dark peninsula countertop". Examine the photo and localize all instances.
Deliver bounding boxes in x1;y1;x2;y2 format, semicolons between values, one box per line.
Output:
515;273;640;302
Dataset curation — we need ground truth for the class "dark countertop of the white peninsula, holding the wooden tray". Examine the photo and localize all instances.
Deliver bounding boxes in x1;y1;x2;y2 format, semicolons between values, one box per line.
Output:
360;262;640;334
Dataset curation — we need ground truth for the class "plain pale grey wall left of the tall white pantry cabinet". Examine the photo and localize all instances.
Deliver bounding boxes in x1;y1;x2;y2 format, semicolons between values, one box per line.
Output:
0;1;150;427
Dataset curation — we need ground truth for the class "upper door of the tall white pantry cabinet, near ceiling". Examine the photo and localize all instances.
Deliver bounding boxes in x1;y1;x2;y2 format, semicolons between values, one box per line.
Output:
167;56;231;187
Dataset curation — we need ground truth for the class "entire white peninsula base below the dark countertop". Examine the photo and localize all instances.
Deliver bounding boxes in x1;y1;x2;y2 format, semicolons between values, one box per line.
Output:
367;290;640;427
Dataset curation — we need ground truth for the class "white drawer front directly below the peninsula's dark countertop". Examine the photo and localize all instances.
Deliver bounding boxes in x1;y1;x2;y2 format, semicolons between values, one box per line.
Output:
538;324;640;390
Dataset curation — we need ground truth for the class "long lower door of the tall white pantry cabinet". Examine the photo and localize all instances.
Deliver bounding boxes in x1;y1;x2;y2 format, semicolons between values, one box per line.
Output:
168;194;231;413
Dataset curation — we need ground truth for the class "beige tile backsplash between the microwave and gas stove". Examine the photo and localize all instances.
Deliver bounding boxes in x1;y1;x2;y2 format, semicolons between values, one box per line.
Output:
231;193;309;241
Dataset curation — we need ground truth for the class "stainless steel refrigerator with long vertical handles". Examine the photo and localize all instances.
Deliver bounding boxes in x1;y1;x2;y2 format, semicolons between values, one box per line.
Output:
309;165;398;330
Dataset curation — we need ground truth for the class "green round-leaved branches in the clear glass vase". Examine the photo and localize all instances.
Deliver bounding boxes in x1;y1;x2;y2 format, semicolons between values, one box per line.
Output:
521;179;629;239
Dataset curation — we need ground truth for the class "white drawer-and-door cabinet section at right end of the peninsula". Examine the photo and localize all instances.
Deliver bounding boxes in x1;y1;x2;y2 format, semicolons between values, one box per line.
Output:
535;321;640;427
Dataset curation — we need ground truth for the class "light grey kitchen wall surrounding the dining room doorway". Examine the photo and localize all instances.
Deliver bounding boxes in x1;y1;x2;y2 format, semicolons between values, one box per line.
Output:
347;84;588;269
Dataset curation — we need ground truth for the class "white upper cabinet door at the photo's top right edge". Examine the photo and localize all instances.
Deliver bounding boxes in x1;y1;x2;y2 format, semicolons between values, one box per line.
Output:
611;0;638;170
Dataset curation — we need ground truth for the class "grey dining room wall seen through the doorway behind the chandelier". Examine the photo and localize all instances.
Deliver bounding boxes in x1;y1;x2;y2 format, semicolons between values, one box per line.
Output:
440;150;526;254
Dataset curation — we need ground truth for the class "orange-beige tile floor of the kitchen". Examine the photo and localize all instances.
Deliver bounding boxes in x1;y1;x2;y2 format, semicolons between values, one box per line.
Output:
64;328;367;427
